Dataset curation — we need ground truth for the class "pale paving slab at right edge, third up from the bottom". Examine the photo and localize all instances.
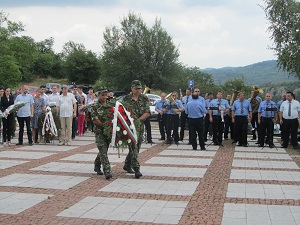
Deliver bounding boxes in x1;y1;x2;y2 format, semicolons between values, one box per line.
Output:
230;169;300;181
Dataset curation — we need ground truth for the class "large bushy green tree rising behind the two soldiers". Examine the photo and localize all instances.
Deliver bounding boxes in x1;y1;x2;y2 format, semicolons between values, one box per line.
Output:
102;13;179;90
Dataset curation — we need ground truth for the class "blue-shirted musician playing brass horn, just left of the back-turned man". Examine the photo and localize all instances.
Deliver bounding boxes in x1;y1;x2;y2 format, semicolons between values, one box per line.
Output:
163;91;184;145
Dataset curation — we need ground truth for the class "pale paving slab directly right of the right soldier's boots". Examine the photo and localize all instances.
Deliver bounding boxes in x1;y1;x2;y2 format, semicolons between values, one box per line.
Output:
141;166;207;178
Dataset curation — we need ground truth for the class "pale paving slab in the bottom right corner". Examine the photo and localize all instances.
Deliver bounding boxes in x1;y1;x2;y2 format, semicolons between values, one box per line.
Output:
222;203;300;225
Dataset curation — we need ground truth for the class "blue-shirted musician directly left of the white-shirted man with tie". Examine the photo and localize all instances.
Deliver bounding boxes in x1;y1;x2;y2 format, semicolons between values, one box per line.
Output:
258;93;278;148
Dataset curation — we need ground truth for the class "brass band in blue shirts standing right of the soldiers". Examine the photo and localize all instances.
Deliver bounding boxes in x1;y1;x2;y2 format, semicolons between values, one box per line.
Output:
155;88;300;150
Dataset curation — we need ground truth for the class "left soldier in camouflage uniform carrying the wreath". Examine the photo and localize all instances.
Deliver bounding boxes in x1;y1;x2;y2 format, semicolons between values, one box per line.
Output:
91;87;112;180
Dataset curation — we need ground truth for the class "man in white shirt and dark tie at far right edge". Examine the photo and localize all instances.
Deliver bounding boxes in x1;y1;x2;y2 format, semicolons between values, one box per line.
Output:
279;92;300;149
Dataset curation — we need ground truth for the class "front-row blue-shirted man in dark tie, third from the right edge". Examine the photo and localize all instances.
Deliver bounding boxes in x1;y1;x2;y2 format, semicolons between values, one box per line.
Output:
231;92;252;147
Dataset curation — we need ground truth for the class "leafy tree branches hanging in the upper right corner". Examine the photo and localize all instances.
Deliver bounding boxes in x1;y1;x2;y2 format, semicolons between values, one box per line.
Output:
263;0;300;79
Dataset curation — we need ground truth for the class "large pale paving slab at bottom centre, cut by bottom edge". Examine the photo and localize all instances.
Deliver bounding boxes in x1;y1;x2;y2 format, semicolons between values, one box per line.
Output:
57;196;188;224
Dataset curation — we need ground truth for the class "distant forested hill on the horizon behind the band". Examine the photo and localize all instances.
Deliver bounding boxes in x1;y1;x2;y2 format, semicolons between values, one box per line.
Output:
201;60;298;86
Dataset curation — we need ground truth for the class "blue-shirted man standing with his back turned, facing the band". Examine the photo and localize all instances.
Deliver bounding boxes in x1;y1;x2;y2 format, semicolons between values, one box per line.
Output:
186;94;207;150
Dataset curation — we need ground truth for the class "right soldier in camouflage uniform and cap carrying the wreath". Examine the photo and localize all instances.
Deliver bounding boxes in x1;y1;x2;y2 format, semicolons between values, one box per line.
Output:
122;80;150;178
